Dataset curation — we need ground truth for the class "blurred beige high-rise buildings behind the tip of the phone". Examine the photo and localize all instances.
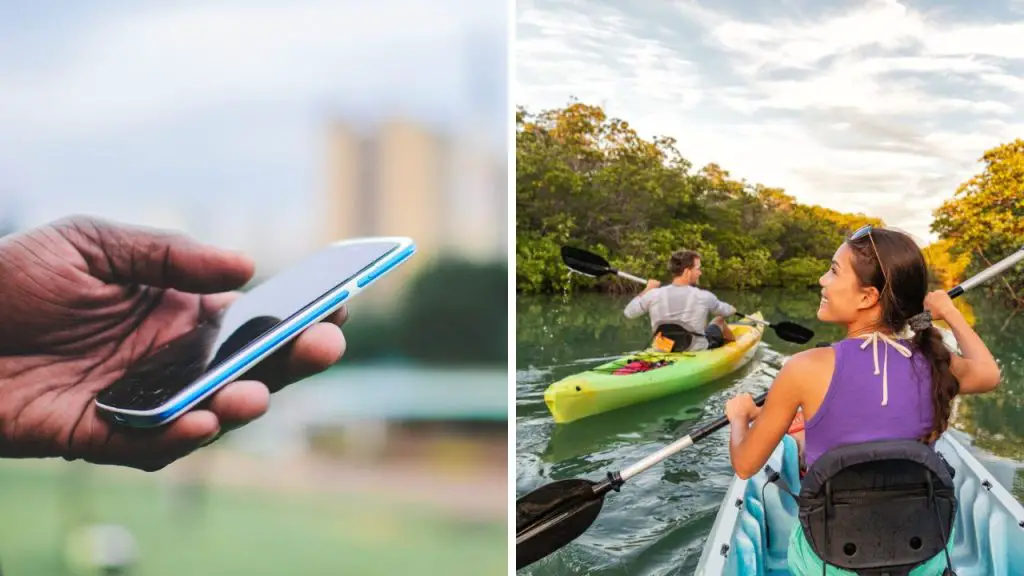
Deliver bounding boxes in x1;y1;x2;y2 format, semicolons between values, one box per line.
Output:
318;119;508;299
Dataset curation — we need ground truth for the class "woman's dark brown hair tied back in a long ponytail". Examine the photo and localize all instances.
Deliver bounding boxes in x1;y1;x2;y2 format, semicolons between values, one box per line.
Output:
847;229;959;442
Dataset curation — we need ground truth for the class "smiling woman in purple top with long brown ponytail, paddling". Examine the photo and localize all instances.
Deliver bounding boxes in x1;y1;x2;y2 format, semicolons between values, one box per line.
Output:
725;227;1000;575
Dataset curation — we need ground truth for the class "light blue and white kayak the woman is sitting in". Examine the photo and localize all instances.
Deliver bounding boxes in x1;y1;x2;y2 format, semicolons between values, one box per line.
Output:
695;431;1024;576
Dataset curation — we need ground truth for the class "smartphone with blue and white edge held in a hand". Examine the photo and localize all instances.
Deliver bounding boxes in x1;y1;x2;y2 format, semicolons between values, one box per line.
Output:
95;237;416;427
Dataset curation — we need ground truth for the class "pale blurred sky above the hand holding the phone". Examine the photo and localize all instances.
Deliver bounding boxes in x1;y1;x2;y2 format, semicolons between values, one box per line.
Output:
0;0;510;262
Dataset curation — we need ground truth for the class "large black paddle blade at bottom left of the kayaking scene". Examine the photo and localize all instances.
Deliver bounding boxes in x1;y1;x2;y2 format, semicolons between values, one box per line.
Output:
515;479;604;570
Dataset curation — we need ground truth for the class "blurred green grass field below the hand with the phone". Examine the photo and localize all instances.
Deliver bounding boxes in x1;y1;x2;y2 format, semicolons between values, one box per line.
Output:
0;462;508;576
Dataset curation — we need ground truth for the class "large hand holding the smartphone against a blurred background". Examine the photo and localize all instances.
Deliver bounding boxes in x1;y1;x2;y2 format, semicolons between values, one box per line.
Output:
0;217;346;471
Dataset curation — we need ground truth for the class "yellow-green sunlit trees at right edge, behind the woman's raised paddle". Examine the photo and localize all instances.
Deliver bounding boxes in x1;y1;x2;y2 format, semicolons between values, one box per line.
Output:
932;139;1024;307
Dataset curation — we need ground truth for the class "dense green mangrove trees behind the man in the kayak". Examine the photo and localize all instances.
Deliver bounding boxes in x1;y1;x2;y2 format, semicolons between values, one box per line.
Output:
516;101;882;293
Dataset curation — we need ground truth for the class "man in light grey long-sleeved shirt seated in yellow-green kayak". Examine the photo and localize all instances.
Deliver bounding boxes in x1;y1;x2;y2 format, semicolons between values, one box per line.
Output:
625;250;736;352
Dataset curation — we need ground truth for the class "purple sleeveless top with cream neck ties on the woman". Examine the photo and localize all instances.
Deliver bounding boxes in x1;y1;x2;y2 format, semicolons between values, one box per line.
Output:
804;338;933;467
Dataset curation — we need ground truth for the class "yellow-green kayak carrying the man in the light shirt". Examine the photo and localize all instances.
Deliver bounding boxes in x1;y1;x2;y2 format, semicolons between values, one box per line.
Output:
544;312;764;423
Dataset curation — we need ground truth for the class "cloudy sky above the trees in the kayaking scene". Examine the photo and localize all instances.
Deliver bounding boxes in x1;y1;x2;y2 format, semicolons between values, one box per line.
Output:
515;0;1024;241
